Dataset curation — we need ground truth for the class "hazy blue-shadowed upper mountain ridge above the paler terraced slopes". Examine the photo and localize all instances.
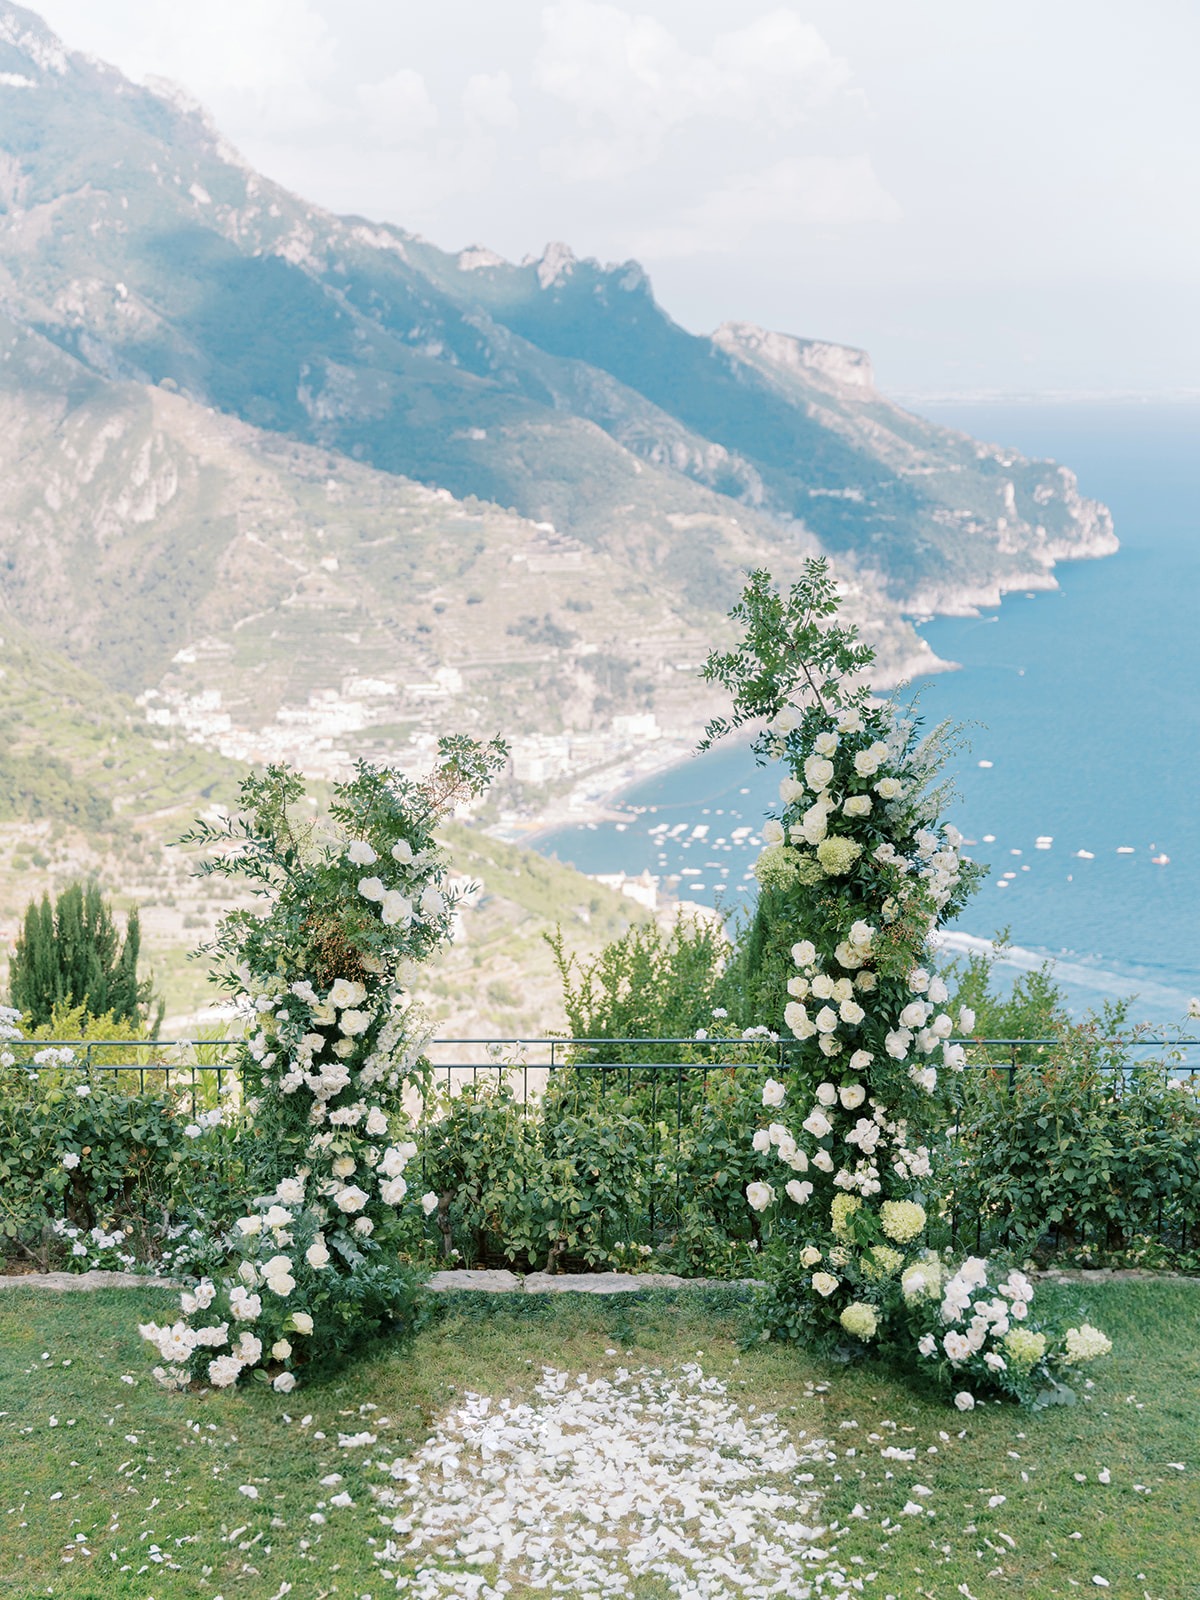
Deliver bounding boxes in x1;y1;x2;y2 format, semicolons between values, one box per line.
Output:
0;8;1104;630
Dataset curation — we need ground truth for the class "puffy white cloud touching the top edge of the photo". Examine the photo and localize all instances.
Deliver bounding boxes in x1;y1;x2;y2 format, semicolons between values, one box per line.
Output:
534;0;850;178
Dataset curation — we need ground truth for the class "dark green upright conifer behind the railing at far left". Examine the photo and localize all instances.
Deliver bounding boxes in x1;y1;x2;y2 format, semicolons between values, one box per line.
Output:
10;882;152;1027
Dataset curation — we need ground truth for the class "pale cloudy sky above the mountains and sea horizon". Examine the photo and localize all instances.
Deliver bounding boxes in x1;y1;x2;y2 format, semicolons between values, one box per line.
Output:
35;0;1200;395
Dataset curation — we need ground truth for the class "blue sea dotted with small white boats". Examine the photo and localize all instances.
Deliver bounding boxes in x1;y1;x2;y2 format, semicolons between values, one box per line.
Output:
538;400;1200;1024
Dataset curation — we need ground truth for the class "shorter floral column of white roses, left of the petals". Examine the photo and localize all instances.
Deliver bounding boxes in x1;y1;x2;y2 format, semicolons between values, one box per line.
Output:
141;738;507;1394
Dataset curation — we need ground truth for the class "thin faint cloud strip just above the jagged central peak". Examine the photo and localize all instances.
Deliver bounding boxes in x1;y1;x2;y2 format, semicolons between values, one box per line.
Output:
635;155;901;259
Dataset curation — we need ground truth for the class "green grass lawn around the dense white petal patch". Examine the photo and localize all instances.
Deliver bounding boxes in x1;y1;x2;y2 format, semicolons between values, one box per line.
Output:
0;1282;1200;1600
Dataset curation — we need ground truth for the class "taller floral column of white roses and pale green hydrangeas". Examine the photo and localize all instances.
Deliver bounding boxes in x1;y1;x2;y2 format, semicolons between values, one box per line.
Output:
702;560;1107;1410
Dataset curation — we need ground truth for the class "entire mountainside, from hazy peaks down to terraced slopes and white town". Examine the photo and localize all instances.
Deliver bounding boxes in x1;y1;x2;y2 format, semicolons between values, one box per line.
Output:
0;0;1115;1030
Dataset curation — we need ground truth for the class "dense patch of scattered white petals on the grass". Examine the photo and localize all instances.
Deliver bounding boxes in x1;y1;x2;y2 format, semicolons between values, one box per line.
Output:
373;1363;850;1600
